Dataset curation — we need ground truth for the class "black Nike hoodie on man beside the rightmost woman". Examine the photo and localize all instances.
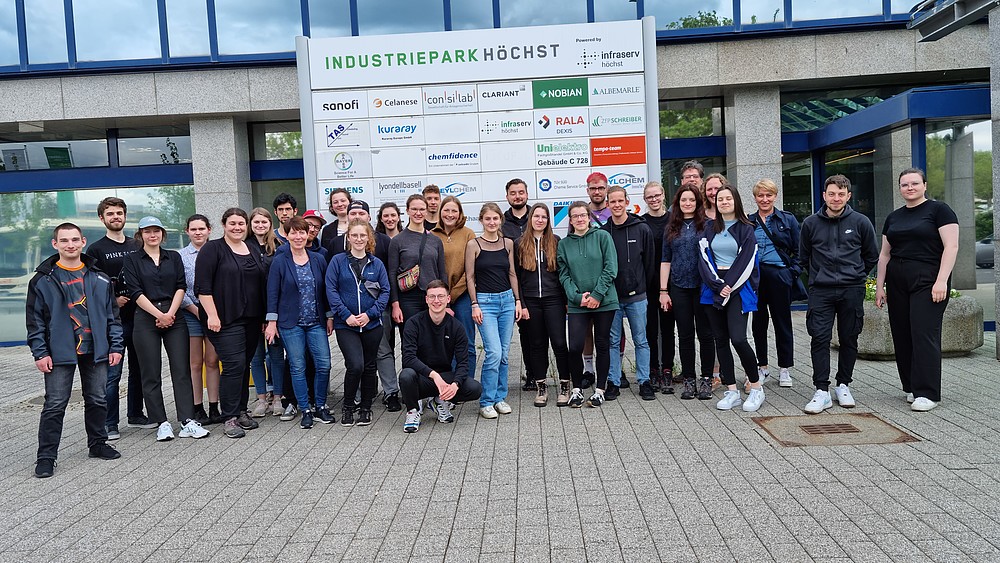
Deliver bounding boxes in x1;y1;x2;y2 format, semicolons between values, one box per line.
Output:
799;205;878;287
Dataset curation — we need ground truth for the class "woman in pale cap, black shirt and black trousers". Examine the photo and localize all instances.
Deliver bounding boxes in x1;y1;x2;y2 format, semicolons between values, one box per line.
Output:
122;217;208;442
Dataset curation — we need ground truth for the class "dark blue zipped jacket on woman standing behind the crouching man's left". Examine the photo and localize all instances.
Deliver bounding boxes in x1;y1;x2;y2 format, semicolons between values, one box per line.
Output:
326;252;389;332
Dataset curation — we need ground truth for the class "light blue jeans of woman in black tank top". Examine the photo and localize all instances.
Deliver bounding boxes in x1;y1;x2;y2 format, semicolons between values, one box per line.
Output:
476;289;514;407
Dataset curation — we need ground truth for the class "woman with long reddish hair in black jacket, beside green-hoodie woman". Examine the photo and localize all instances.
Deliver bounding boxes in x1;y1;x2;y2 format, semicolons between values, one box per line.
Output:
514;203;573;407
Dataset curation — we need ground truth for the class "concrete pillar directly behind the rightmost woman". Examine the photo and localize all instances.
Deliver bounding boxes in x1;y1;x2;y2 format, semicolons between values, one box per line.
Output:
944;131;976;289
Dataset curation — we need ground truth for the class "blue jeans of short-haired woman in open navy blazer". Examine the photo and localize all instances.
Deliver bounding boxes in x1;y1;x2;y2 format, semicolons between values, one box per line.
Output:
278;322;330;411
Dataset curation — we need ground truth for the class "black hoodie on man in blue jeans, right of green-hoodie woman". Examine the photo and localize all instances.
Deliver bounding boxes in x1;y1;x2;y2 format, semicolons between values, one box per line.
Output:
601;213;660;303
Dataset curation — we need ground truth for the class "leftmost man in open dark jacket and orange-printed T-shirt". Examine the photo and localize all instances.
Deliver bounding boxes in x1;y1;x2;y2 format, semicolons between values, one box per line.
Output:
25;223;125;478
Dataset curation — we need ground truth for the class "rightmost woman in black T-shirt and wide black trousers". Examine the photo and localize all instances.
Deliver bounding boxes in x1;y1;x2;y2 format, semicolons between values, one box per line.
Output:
875;168;958;411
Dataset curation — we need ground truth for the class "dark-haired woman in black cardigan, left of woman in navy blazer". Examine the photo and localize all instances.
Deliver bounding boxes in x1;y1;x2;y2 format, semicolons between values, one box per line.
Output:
195;207;267;438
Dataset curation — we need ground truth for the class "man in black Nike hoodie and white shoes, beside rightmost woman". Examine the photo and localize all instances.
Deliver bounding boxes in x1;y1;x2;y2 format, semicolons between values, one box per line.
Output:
799;174;878;414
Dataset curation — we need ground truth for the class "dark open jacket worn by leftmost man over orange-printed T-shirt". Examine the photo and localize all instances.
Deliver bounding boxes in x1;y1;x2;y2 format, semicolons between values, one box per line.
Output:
25;254;125;366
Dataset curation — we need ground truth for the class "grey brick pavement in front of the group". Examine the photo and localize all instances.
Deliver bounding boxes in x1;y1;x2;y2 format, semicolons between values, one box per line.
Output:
0;313;1000;562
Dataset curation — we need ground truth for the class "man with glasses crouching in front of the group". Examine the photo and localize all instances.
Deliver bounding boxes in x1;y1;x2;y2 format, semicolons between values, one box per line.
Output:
399;280;483;432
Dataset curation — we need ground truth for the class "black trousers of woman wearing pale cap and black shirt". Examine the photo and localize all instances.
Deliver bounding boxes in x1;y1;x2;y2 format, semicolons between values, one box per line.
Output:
132;303;194;424
